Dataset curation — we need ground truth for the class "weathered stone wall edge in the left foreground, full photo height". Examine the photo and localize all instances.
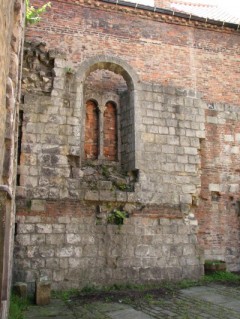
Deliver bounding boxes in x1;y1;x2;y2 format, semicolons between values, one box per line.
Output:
0;1;24;319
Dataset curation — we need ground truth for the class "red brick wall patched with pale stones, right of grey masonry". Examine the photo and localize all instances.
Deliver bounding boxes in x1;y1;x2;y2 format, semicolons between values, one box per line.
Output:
196;104;240;270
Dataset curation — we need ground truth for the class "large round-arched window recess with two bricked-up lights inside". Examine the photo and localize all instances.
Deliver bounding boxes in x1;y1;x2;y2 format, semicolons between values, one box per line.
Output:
76;56;141;171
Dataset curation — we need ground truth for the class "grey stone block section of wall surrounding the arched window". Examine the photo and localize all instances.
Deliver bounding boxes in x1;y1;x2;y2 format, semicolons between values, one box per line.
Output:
15;40;205;289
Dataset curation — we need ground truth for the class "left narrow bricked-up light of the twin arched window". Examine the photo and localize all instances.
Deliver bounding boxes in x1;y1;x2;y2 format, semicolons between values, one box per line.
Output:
84;100;99;160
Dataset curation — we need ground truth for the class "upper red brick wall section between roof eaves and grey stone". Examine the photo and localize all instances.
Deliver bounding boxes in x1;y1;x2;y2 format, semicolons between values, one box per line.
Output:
26;0;240;104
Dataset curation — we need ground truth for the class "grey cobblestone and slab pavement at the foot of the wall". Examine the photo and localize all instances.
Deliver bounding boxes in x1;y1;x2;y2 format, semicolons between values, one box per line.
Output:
25;284;240;319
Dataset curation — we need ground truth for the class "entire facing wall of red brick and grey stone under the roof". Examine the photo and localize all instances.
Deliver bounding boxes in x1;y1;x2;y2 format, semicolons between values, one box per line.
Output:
15;1;239;289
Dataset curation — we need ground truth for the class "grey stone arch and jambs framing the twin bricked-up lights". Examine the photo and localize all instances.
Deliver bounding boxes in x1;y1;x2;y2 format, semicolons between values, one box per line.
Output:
76;56;139;171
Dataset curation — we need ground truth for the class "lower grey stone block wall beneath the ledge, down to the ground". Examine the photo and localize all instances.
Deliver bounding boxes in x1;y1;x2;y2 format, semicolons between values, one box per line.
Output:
15;200;201;289
